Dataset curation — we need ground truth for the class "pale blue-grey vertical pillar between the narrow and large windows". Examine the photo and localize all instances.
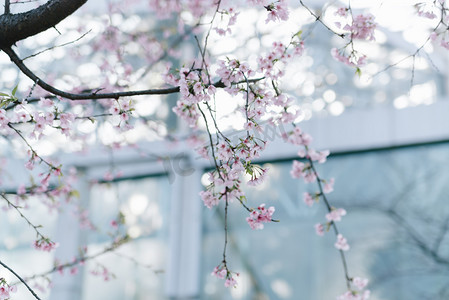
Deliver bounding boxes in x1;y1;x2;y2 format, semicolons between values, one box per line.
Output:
165;158;202;300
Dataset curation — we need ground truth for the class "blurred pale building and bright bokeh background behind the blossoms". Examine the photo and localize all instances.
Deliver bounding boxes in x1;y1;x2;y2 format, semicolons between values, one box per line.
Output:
0;1;449;300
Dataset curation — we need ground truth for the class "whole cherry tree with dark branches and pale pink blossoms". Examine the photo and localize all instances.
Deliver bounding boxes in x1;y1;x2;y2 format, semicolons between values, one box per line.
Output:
0;0;449;300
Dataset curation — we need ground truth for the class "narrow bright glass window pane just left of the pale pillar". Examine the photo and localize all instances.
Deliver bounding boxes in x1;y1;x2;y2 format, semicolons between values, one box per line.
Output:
83;177;170;300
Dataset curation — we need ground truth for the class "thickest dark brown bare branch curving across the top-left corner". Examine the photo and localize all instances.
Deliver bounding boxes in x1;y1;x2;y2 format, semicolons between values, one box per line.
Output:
0;0;87;46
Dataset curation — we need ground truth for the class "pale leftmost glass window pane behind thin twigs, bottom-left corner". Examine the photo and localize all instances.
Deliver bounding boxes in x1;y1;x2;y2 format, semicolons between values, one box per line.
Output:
0;194;58;299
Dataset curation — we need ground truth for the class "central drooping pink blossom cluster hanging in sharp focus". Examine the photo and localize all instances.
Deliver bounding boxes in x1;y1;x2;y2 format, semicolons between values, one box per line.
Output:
166;13;303;287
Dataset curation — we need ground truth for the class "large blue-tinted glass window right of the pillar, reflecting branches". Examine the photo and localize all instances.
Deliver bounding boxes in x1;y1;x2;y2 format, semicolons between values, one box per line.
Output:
202;143;449;300
